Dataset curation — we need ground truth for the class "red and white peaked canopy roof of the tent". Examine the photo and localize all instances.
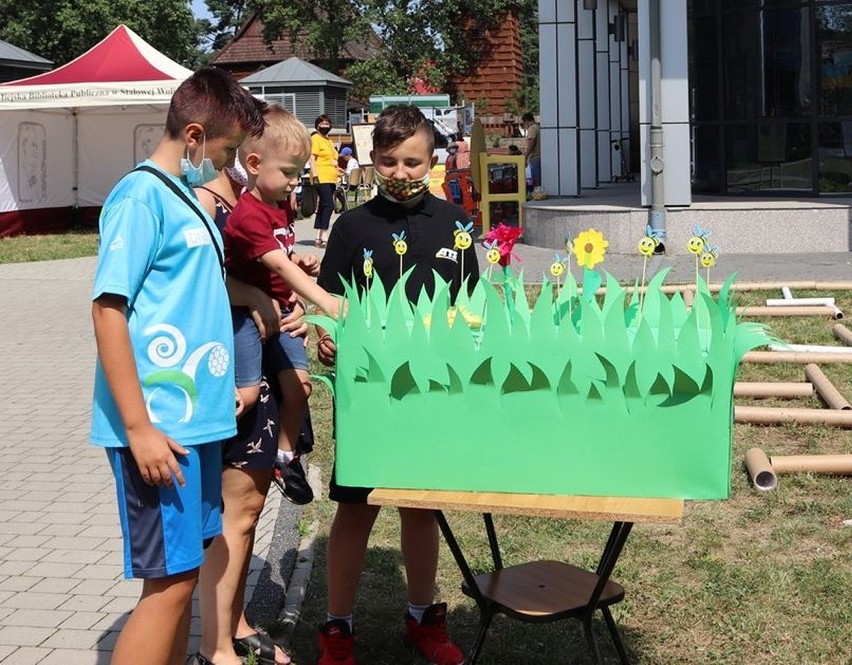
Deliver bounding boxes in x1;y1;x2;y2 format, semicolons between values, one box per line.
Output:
0;25;192;110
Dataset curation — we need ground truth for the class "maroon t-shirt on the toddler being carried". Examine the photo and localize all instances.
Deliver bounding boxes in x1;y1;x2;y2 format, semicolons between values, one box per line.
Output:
223;192;296;305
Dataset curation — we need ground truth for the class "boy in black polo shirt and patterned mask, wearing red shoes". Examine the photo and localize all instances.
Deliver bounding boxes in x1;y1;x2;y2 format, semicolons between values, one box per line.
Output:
318;106;479;665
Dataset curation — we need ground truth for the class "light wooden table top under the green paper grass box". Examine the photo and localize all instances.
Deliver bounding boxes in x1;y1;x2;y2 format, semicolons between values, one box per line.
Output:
367;489;683;524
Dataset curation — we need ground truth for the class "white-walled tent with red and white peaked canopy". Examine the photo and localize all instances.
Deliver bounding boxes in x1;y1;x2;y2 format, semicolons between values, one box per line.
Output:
0;25;192;237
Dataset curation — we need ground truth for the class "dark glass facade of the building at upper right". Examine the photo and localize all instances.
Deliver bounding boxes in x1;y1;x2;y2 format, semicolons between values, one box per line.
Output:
688;0;852;197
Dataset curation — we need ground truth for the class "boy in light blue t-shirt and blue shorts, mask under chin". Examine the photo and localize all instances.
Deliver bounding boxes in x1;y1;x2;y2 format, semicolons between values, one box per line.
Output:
91;67;264;665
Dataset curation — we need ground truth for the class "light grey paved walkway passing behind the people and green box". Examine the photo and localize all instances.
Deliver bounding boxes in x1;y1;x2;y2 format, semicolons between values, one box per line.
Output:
0;232;852;665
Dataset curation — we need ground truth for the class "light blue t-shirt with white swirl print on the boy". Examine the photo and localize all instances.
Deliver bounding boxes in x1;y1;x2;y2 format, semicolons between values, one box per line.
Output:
91;161;236;447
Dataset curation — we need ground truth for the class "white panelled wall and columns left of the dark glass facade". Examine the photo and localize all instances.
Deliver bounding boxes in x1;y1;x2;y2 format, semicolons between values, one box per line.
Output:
539;0;692;206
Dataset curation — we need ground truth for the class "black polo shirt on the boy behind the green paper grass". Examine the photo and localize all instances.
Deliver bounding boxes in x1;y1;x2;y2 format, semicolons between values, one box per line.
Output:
317;193;479;302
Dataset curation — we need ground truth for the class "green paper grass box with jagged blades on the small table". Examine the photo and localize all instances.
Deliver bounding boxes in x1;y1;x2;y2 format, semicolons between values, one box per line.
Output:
313;270;771;499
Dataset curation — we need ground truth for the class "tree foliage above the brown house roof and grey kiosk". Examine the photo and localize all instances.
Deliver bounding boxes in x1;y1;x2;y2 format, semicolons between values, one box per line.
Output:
220;0;538;105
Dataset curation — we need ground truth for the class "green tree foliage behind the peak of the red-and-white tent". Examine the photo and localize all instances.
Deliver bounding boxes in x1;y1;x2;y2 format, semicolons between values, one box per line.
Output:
0;0;203;67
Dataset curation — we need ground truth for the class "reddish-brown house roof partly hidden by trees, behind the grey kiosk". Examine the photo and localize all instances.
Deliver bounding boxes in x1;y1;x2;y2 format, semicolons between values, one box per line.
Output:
212;14;381;65
